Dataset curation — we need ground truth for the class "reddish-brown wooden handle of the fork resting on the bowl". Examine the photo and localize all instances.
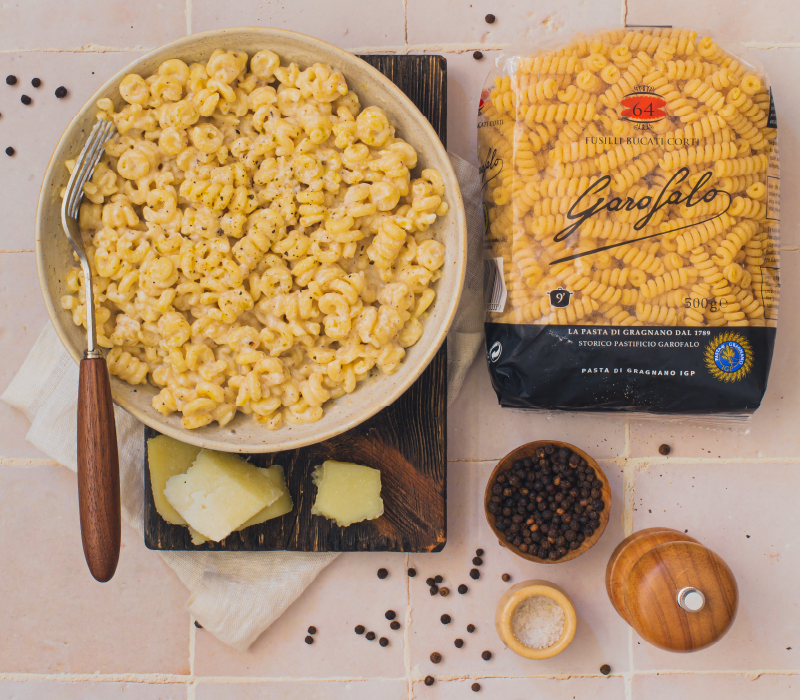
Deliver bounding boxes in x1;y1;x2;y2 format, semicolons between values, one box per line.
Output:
78;357;121;582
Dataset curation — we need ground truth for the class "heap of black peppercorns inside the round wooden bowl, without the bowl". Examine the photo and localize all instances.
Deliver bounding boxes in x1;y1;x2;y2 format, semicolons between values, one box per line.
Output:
487;443;606;561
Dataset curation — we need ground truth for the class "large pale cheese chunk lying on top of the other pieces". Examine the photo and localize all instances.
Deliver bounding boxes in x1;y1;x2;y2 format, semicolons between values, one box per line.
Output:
164;450;281;542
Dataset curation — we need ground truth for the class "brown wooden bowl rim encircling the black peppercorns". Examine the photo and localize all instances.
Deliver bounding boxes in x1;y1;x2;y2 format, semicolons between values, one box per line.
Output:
483;440;611;564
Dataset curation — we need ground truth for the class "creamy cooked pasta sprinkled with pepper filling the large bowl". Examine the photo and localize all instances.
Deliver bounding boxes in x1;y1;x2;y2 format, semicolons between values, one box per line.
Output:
61;49;448;429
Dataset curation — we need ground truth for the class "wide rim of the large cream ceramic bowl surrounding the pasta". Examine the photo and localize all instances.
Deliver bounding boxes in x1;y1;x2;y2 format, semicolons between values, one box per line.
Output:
36;27;467;452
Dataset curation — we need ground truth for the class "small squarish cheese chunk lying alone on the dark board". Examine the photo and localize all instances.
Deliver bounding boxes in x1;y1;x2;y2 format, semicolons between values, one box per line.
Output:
311;461;383;527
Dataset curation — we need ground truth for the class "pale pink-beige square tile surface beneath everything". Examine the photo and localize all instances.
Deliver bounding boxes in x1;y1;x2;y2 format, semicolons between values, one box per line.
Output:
0;0;800;700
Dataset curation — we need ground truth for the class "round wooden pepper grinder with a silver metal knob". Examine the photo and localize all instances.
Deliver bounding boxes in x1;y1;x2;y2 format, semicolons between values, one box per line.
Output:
606;527;739;652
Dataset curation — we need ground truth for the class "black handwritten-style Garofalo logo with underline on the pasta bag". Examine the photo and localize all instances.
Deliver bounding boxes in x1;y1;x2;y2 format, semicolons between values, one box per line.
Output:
550;168;731;265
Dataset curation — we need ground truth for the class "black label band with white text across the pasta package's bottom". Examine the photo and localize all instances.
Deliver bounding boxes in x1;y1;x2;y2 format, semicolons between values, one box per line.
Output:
485;323;775;414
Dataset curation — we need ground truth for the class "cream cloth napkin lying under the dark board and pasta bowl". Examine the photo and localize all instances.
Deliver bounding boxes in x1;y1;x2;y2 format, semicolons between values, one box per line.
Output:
0;154;483;651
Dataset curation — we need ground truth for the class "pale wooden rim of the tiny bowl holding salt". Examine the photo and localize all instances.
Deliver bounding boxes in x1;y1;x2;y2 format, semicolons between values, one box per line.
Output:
494;579;578;659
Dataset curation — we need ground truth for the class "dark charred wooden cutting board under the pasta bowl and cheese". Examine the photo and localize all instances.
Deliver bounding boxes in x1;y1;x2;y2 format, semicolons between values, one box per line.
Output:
144;56;447;552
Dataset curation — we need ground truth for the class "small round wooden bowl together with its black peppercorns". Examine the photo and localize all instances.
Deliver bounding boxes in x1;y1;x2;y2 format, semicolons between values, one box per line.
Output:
484;440;611;564
